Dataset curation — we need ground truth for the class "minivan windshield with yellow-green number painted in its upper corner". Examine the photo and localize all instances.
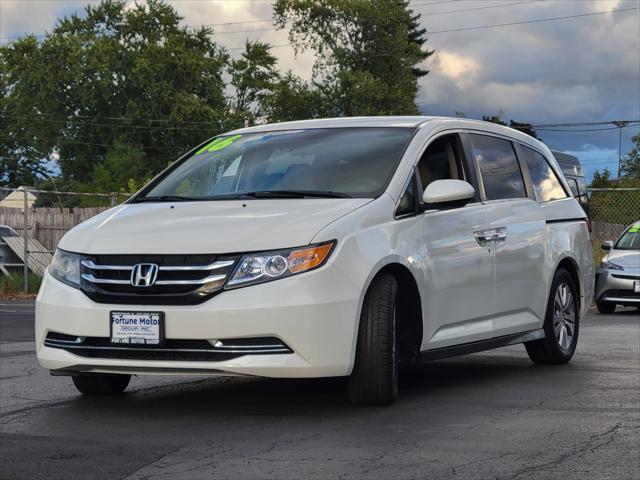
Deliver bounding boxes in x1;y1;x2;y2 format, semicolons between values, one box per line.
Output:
135;128;413;201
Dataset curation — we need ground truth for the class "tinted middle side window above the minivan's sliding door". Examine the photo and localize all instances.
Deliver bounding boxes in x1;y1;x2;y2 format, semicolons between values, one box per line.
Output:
469;134;527;200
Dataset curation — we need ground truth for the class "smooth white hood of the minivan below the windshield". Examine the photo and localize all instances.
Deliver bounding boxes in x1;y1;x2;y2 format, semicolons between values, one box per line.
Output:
58;198;371;254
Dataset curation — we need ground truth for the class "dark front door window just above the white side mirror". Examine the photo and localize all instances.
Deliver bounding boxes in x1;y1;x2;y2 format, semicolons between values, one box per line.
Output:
418;134;465;189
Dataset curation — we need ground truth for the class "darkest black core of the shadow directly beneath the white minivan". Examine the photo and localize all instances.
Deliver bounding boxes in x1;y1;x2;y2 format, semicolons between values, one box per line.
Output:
57;355;536;419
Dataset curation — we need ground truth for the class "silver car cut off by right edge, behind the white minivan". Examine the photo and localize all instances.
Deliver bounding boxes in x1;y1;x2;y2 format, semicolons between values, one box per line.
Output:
595;221;640;313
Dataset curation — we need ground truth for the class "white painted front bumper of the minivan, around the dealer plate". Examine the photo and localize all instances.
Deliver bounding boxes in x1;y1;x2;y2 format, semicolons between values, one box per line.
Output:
36;264;360;377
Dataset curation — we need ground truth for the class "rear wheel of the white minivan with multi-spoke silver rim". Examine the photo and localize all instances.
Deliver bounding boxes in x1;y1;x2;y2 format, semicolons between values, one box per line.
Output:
524;269;580;365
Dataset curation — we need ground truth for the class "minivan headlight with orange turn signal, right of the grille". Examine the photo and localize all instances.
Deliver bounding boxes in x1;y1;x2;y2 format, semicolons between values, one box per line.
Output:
225;242;335;288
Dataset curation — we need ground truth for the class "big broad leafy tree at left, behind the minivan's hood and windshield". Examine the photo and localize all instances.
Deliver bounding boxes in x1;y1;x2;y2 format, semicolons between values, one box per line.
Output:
0;0;230;190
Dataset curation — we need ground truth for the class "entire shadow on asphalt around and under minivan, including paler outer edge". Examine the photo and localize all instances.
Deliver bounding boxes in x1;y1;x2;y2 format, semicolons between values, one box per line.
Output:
18;352;592;441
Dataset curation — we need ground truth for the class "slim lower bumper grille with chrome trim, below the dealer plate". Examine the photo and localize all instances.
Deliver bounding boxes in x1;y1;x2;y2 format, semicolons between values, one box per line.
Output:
44;332;293;362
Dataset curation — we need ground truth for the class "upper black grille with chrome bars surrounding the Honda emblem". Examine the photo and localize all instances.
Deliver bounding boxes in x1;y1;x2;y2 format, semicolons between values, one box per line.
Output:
80;255;238;305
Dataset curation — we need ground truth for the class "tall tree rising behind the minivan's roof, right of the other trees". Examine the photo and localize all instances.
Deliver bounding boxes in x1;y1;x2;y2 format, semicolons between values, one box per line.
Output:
274;0;433;116
